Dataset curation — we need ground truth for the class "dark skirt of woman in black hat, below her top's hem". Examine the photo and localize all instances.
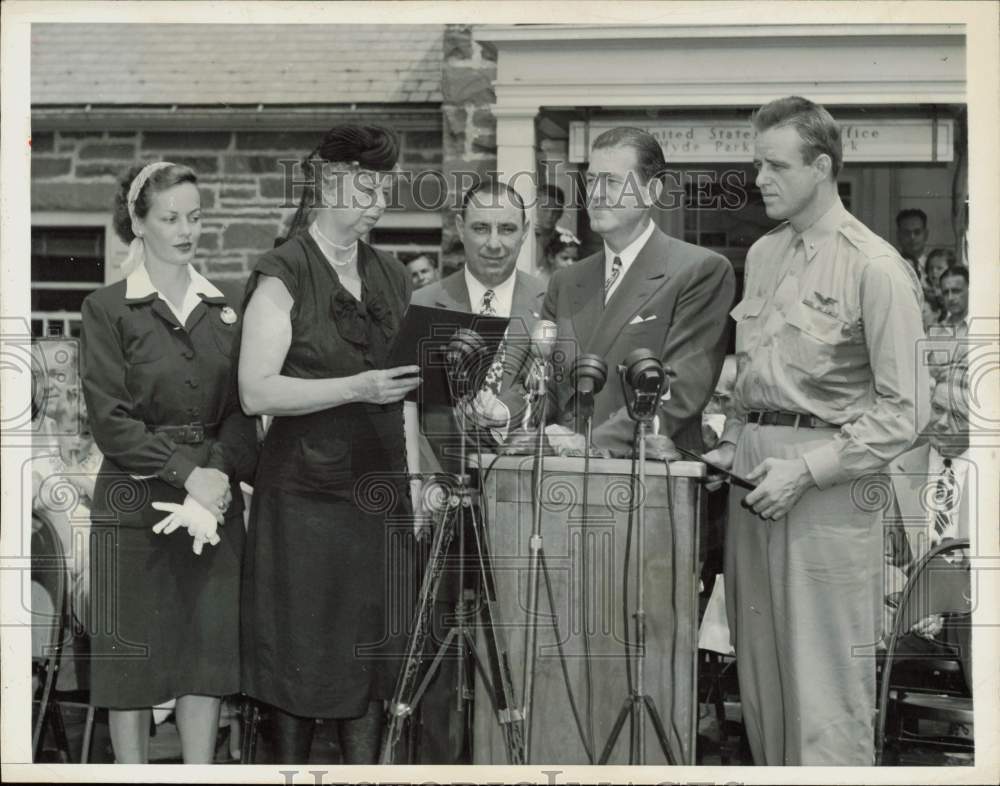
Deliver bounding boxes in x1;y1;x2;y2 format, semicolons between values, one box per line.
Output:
241;488;416;718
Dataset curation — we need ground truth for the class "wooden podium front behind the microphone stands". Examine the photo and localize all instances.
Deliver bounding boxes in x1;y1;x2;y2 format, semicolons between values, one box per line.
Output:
473;456;705;764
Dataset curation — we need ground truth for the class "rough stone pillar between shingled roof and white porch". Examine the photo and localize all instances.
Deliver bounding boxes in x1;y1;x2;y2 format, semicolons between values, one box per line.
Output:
441;25;497;269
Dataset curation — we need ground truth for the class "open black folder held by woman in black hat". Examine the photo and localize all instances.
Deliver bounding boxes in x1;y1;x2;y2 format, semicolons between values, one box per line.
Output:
387;305;510;406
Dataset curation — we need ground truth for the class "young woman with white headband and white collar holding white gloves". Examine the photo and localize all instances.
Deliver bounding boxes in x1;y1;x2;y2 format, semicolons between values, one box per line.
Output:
81;162;256;764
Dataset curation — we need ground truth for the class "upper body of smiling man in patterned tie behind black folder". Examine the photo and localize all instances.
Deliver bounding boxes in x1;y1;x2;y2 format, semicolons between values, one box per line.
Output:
411;179;545;472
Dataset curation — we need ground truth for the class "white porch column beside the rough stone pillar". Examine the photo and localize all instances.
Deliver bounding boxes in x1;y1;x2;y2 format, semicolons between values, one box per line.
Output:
493;105;538;273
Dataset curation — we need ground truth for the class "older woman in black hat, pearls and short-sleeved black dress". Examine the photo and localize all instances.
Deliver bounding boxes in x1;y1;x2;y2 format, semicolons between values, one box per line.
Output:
239;126;419;764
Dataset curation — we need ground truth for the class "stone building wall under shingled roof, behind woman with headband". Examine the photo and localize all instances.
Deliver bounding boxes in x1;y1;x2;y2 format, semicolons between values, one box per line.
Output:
31;124;442;279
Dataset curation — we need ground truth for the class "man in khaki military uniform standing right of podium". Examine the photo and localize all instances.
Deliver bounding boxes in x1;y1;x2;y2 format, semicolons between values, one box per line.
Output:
708;97;929;766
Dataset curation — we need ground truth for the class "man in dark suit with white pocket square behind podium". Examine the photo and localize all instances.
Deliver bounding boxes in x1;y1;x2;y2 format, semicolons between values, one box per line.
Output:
542;127;735;458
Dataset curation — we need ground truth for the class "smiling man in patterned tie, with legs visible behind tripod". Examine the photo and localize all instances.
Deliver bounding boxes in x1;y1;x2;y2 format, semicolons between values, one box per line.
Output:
411;179;545;764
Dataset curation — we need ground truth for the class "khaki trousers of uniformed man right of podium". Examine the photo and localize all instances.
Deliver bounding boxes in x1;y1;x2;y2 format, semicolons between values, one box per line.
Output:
725;424;888;766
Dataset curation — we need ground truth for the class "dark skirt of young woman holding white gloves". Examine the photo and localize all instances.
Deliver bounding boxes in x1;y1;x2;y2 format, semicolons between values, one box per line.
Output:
87;511;245;709
